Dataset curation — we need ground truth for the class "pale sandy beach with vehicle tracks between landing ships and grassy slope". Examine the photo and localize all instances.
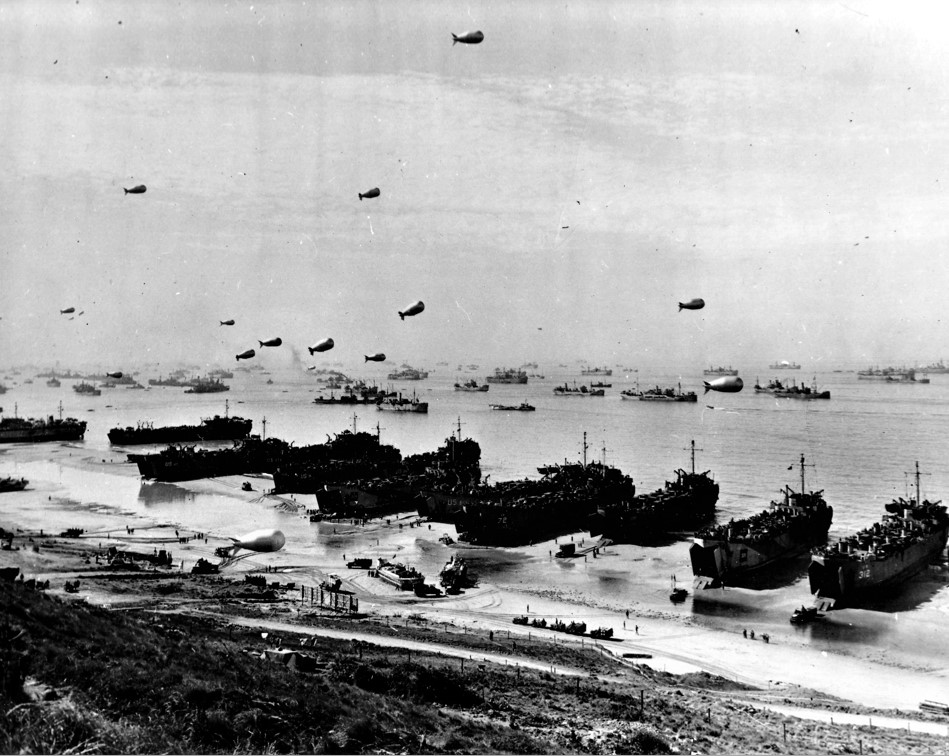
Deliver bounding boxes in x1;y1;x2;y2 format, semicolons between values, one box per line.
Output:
0;447;949;711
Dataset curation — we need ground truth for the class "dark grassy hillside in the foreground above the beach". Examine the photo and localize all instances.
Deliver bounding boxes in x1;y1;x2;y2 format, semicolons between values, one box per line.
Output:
0;578;946;753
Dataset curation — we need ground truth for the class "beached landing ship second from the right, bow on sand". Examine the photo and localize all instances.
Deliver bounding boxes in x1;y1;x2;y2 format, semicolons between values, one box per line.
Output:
689;454;834;590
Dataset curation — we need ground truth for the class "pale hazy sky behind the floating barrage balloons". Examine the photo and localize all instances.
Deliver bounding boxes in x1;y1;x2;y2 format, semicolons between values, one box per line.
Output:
0;0;949;371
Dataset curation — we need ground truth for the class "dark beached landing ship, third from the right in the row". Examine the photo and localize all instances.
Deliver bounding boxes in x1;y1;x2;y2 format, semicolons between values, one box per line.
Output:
588;440;718;543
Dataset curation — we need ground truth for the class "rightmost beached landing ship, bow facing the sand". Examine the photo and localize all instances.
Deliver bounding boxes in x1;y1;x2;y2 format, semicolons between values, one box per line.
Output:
807;462;949;611
